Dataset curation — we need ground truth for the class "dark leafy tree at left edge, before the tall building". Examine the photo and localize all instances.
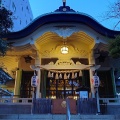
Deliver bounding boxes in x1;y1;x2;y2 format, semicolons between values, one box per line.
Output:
0;7;13;55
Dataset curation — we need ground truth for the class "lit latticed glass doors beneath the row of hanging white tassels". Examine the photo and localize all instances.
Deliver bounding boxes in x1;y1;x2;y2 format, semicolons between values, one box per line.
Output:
46;78;82;99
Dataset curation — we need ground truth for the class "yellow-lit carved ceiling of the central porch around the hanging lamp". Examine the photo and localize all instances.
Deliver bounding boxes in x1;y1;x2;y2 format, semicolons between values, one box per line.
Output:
35;32;95;59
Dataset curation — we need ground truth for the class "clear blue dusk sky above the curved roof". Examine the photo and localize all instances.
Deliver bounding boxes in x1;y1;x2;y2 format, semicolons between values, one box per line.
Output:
29;0;119;30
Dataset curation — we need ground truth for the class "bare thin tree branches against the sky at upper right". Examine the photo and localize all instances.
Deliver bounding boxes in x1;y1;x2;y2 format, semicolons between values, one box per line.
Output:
103;0;120;29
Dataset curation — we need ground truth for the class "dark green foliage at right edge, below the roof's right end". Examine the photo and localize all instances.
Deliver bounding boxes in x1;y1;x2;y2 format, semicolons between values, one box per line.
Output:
108;35;120;58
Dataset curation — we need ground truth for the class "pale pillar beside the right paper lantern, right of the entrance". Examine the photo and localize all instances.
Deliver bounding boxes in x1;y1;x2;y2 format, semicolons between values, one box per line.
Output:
89;50;95;98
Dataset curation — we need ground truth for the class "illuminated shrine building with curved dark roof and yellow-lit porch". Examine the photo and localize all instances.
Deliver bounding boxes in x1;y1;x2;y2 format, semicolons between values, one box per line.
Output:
0;3;120;99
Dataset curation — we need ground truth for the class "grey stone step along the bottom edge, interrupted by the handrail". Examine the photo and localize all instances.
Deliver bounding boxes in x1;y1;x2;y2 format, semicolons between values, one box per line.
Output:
0;114;120;120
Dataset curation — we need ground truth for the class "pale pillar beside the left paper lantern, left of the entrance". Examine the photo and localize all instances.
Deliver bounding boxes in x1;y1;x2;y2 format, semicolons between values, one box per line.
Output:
35;53;41;98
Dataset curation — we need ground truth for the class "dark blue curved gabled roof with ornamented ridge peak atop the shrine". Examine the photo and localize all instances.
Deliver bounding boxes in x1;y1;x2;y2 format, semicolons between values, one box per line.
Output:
5;6;120;40
